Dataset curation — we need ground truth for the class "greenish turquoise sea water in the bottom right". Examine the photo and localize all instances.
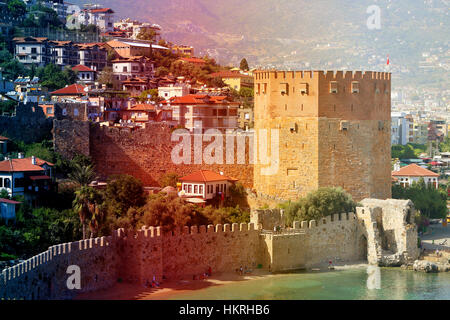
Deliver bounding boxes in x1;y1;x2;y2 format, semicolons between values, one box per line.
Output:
173;267;450;300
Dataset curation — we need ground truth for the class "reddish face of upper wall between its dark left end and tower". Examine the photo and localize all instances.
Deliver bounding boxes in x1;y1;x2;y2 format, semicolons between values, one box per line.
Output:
89;125;253;188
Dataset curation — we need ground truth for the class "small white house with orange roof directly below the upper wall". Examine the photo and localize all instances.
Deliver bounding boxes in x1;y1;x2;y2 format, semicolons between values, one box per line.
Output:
180;170;238;202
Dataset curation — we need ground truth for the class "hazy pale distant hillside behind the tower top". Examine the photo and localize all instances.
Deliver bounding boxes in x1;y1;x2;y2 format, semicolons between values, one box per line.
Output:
75;0;450;87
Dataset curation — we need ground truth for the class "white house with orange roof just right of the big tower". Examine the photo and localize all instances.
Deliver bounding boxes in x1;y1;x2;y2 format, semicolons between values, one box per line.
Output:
392;163;439;189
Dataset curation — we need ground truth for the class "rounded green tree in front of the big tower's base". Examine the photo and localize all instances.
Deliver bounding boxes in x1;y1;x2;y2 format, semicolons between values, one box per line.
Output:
284;187;356;224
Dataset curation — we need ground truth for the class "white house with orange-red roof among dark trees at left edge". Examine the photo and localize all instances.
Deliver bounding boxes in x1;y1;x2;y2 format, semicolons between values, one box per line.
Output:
0;156;54;197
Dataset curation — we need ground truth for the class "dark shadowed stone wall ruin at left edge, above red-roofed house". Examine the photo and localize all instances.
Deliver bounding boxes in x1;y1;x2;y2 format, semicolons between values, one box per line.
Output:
0;103;52;143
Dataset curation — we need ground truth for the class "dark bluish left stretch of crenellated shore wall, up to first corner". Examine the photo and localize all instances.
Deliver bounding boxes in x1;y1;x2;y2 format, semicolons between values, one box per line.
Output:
0;237;118;300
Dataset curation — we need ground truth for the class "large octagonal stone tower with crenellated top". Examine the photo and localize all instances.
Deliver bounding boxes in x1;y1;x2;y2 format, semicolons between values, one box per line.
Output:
254;71;391;201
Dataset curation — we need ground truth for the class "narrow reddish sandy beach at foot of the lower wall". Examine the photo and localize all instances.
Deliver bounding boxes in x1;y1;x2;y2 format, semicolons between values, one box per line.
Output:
75;270;278;300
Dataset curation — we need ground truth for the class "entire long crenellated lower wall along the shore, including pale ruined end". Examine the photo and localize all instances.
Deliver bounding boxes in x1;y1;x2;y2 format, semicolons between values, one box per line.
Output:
0;199;419;299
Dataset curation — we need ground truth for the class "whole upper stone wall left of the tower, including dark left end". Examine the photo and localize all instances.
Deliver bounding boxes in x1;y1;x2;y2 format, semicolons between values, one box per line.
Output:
53;120;253;188
